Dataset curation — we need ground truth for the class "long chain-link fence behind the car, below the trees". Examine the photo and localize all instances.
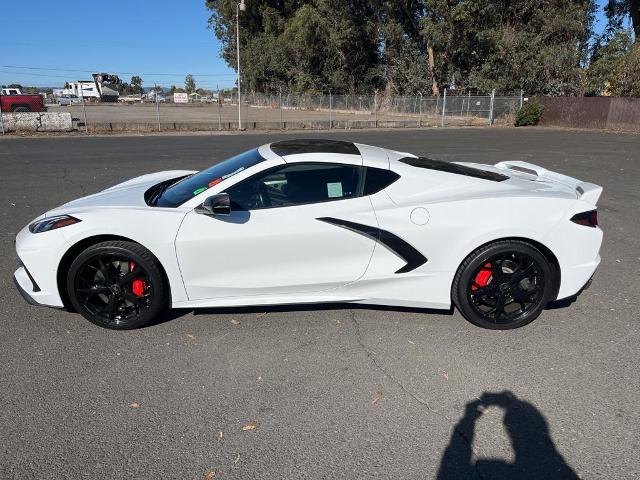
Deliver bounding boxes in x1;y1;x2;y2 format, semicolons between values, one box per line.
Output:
0;86;522;133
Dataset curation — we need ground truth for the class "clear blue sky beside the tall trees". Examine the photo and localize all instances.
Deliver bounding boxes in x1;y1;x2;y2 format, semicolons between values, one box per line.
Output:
0;0;607;89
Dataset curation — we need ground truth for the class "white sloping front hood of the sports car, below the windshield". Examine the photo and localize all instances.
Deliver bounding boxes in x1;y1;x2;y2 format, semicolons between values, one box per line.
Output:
47;170;196;215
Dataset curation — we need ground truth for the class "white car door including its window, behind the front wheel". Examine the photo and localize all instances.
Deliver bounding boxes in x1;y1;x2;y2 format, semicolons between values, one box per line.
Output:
176;162;377;300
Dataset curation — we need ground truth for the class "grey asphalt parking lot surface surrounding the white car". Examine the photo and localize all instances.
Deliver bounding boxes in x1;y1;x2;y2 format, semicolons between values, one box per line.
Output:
0;128;640;480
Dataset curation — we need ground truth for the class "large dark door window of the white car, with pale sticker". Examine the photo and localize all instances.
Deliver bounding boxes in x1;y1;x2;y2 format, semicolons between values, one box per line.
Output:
226;163;362;210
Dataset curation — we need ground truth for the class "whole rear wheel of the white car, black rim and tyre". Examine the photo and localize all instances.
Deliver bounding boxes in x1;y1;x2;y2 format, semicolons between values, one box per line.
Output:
452;240;555;330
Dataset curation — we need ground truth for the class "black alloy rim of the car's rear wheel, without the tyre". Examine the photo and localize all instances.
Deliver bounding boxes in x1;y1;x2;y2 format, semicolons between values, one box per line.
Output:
467;252;545;324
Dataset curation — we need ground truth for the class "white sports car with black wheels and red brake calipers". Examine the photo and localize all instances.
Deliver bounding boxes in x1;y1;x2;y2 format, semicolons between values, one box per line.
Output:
14;140;602;329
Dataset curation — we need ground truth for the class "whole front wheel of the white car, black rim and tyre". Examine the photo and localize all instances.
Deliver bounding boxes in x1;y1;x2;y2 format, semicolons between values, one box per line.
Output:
67;241;169;330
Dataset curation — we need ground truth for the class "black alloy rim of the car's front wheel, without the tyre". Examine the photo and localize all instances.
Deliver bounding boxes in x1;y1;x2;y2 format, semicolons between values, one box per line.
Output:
74;254;153;326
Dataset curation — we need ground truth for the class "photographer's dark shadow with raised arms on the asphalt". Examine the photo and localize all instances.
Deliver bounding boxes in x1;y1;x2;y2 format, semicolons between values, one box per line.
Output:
437;391;578;480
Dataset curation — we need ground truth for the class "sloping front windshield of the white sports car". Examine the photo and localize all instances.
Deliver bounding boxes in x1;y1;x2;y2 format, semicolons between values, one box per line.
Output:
154;148;265;208
